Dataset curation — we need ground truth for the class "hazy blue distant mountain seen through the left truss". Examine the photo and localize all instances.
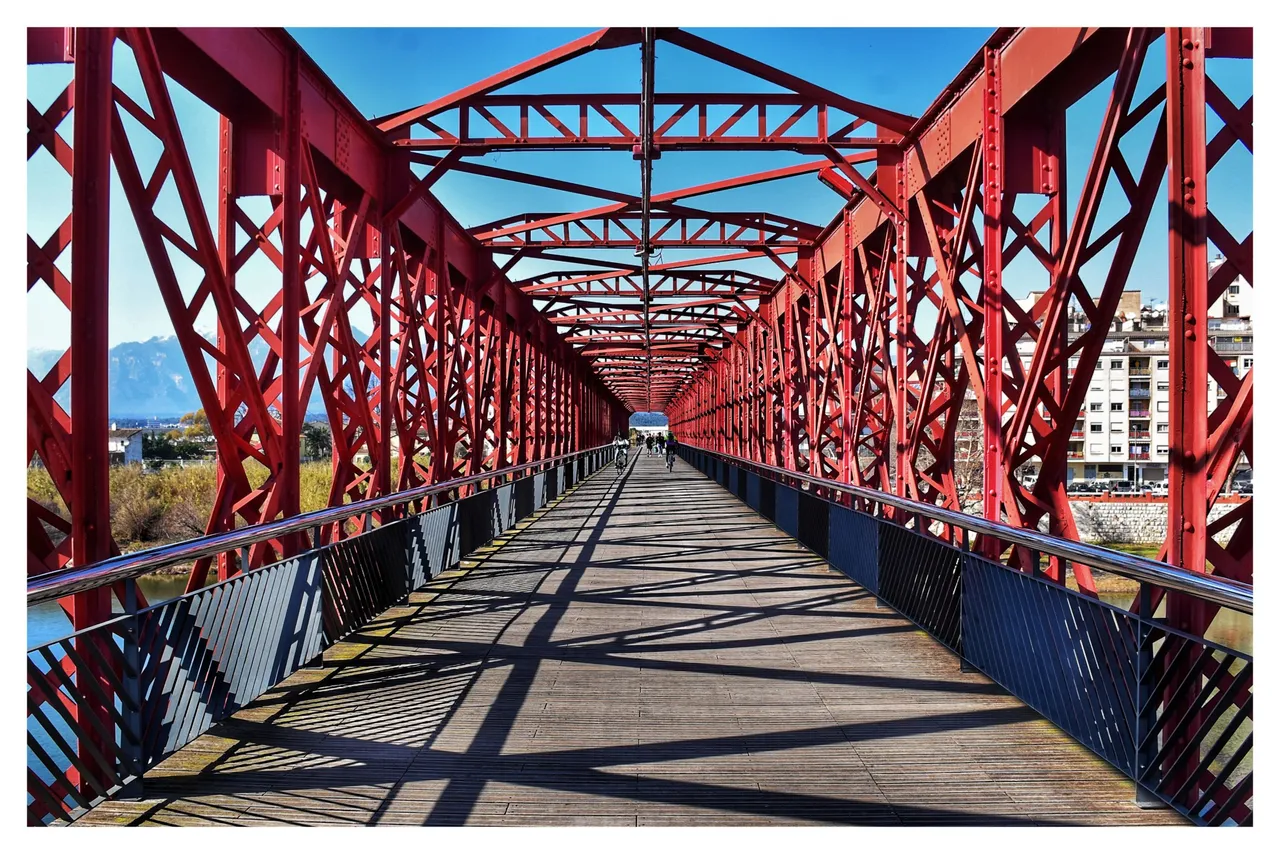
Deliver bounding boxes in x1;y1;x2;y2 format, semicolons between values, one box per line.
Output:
27;330;367;419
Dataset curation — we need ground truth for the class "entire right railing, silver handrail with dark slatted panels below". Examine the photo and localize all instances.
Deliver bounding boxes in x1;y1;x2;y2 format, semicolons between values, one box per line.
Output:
682;444;1253;825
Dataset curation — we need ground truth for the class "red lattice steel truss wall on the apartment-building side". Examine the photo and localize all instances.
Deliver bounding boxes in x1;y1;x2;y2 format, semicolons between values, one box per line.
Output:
668;29;1252;614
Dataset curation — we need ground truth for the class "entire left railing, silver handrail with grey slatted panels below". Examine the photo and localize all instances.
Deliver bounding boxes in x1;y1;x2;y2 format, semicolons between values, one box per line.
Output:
27;446;609;825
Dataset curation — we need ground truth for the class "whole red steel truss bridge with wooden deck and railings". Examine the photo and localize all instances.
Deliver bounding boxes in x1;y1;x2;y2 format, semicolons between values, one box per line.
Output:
27;27;1253;825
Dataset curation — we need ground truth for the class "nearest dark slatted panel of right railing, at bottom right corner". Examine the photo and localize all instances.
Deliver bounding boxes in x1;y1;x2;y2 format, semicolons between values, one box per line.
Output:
1138;624;1253;826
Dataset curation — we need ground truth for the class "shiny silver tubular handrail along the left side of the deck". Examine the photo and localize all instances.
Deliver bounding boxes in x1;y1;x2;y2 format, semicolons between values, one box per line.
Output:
27;444;609;607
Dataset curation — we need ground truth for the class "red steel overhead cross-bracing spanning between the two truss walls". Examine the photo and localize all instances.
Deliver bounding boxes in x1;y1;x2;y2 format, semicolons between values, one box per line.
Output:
376;28;914;410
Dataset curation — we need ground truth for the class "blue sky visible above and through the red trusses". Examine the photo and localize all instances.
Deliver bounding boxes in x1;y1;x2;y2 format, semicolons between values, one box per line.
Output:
27;28;1253;350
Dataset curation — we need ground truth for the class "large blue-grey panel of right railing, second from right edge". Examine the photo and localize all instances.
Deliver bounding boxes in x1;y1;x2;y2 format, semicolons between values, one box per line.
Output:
961;554;1138;777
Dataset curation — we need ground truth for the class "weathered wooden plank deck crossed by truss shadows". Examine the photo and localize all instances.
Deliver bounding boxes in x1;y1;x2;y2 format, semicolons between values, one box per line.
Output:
79;456;1181;826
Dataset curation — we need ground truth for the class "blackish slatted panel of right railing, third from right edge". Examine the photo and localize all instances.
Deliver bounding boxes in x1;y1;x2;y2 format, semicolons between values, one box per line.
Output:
877;521;960;652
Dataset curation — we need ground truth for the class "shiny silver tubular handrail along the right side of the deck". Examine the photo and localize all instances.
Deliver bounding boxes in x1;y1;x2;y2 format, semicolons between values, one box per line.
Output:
682;443;1253;615
